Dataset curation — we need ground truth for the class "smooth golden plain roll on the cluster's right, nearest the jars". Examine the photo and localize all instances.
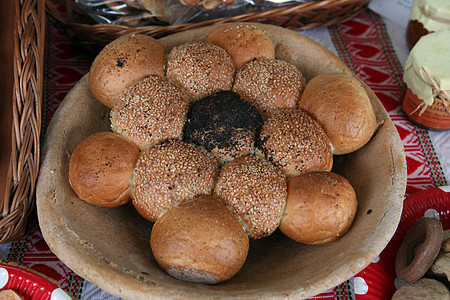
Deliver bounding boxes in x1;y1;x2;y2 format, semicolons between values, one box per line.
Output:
298;73;377;154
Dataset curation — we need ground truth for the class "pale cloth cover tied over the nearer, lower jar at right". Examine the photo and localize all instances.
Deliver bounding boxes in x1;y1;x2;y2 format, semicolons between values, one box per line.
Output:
403;30;450;105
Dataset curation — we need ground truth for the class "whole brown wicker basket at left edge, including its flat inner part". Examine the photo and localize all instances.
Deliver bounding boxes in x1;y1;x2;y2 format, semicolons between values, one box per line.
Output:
0;0;45;243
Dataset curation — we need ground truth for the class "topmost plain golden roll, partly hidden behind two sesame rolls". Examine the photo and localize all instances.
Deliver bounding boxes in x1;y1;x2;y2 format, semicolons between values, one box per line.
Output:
206;23;275;70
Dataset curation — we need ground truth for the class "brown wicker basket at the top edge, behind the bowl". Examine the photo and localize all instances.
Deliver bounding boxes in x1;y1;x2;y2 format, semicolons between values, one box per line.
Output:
47;0;370;51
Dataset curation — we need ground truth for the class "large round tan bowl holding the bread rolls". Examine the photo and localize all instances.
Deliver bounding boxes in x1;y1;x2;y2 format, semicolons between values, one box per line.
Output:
37;24;406;299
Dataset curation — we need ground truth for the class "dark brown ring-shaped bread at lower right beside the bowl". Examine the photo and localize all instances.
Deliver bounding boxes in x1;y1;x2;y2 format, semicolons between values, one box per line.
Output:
395;218;444;283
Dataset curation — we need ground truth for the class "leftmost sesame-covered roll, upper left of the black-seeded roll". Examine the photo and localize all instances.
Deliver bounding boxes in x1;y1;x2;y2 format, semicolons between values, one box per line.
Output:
110;76;189;150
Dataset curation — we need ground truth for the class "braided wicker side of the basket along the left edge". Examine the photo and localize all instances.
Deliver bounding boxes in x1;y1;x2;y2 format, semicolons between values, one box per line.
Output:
0;0;45;243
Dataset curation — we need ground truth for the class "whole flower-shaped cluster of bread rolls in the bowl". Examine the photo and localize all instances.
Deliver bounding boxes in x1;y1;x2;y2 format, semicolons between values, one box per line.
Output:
69;23;376;284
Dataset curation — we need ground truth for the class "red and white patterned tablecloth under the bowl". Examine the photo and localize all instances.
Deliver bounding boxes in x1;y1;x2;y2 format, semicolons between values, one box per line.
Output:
0;4;450;299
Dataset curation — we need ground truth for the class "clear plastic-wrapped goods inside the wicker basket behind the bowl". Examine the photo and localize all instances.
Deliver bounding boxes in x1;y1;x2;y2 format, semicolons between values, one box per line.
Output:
75;0;314;26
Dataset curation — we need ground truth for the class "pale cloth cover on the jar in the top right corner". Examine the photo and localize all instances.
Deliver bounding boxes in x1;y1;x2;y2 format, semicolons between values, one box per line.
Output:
409;0;450;31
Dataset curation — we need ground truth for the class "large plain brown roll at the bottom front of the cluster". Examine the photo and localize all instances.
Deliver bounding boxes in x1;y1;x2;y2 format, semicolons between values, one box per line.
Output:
150;195;249;284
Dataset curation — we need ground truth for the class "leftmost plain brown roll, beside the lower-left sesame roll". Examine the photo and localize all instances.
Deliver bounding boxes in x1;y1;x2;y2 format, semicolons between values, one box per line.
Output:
69;132;140;207
